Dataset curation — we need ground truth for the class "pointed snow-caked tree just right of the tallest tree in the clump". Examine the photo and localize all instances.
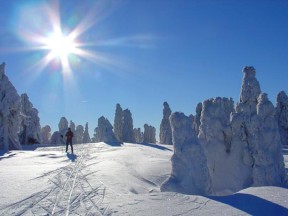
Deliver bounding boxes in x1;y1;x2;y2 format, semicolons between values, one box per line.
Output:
253;93;286;186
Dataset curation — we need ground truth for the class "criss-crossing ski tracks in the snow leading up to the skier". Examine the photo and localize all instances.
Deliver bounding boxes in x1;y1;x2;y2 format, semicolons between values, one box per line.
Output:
0;146;112;216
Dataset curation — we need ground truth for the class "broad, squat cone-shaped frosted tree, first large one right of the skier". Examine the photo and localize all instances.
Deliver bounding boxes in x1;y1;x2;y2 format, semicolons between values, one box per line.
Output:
94;116;118;143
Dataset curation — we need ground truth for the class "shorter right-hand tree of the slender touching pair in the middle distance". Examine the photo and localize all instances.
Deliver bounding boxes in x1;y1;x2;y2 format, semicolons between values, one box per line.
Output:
122;109;135;143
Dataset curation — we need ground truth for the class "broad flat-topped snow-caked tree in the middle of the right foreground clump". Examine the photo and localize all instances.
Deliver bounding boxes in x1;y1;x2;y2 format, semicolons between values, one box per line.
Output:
198;97;250;195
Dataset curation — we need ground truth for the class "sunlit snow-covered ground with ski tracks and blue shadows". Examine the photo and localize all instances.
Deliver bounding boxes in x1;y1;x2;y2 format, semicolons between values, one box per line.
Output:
0;143;288;216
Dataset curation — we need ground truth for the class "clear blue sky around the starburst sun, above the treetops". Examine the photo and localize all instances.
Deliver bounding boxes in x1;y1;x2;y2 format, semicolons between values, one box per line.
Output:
0;0;288;139
